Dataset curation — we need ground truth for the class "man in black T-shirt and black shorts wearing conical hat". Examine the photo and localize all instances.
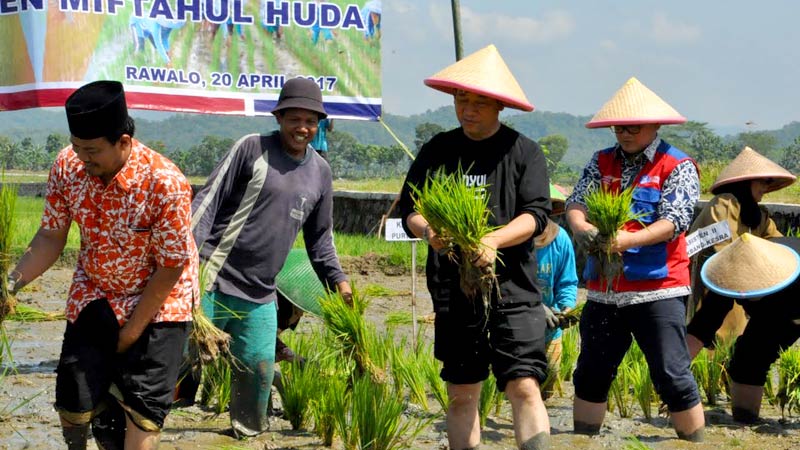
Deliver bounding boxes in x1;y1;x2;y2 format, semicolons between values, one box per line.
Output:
399;45;550;450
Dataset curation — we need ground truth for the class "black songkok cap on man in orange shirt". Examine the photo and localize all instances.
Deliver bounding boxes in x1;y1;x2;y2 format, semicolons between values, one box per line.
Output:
64;80;128;139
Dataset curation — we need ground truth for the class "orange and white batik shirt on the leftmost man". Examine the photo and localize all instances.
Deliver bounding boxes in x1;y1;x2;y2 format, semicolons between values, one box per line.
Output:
41;139;198;325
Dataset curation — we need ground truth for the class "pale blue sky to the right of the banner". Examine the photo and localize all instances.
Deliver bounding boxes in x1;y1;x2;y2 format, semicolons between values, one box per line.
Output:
382;0;800;131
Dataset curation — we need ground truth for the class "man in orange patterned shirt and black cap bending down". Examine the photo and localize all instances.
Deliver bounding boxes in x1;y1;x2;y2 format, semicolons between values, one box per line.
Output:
9;81;197;450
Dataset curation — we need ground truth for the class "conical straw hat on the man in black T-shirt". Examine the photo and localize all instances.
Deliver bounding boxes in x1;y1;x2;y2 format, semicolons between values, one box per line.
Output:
425;45;533;111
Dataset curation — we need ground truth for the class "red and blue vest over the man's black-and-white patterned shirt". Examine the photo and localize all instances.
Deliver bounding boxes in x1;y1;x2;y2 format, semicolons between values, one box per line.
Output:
584;141;694;292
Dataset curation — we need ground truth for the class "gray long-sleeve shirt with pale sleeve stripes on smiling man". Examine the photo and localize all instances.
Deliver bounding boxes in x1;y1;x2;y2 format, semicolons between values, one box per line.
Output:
192;132;347;303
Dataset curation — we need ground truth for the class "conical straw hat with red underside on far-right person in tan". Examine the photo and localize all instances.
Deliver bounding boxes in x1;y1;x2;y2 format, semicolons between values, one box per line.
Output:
711;147;797;194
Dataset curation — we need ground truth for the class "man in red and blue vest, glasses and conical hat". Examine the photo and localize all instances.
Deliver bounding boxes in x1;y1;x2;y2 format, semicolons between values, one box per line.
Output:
567;78;705;441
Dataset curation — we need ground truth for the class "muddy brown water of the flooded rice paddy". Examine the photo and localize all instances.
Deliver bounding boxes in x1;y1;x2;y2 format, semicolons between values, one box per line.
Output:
0;269;800;450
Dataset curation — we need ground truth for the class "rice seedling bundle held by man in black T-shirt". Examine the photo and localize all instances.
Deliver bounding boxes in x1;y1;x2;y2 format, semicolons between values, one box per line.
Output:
411;166;499;308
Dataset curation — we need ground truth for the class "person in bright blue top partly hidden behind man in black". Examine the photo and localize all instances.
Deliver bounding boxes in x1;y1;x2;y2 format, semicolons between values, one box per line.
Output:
533;184;578;399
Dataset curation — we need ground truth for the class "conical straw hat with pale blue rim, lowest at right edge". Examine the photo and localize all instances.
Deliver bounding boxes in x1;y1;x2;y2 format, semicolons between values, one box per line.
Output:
700;233;800;298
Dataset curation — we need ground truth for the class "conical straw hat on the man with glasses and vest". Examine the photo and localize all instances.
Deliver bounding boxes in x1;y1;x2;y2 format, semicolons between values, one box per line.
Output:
586;77;686;128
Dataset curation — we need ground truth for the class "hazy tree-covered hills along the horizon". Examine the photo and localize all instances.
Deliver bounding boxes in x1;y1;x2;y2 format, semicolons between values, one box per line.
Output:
0;106;800;168
